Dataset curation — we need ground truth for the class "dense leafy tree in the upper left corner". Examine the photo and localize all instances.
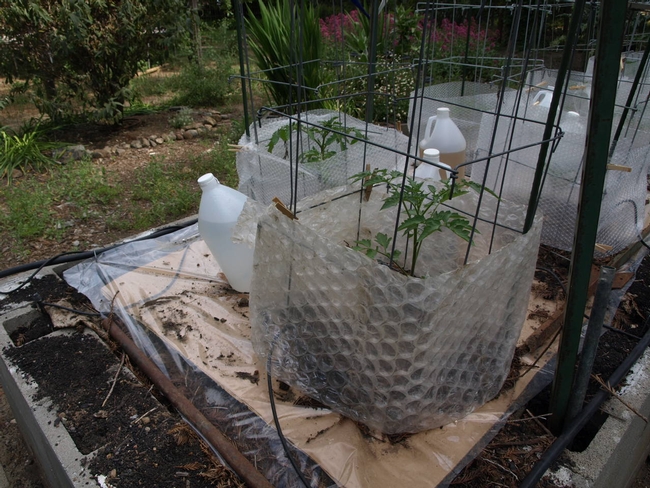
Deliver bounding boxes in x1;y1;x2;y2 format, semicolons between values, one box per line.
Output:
0;0;190;121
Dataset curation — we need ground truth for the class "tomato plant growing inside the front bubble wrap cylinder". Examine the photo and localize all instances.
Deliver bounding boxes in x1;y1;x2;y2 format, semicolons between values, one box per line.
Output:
351;169;478;276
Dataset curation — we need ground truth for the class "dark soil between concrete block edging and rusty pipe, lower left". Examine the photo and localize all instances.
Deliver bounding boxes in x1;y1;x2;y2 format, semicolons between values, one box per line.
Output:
5;276;239;487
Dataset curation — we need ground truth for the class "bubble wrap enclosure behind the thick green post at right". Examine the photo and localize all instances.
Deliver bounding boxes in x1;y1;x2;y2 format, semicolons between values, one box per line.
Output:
472;86;650;256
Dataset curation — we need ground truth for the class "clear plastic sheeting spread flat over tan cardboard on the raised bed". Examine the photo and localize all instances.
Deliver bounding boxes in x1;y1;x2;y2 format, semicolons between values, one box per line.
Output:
65;222;552;488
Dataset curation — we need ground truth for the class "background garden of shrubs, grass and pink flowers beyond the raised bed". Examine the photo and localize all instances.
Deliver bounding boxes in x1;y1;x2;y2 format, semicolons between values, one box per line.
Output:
0;0;548;268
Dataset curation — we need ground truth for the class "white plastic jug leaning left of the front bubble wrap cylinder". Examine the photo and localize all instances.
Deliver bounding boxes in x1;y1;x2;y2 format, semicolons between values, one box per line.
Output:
198;173;253;292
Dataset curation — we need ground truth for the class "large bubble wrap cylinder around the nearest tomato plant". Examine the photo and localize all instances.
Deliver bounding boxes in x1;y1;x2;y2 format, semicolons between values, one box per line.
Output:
250;190;541;434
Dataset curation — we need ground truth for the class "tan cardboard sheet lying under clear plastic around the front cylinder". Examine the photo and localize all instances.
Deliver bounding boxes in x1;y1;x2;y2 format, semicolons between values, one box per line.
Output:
65;227;555;488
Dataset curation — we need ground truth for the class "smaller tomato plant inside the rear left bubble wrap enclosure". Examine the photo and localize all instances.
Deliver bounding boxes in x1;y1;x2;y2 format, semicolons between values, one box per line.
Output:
267;116;365;163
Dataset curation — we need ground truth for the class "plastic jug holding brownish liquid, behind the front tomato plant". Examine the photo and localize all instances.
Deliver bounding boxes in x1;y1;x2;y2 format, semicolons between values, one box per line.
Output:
420;107;467;178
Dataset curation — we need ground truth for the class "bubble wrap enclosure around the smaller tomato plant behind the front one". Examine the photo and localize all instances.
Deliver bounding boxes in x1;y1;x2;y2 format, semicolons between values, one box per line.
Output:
237;110;408;204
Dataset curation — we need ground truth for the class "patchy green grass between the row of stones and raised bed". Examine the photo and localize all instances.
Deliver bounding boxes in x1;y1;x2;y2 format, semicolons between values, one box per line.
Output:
0;134;237;243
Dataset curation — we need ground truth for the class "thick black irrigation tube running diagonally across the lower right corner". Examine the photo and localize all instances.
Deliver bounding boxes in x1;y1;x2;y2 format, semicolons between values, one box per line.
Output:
519;317;650;488
